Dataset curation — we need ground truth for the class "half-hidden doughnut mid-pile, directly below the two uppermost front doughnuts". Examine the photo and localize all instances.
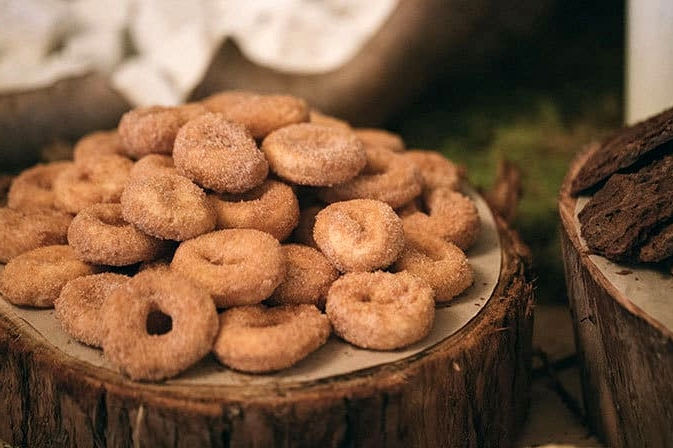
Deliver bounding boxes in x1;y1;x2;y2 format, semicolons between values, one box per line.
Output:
208;179;299;241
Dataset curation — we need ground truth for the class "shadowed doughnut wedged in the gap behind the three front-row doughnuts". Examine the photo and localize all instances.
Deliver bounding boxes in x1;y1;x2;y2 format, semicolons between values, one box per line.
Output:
269;244;339;309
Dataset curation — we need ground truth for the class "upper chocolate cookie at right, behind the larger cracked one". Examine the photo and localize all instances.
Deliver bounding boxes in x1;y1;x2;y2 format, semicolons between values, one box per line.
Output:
570;108;673;195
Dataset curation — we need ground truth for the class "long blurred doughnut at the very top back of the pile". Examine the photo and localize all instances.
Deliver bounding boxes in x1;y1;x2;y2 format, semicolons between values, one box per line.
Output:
202;90;309;140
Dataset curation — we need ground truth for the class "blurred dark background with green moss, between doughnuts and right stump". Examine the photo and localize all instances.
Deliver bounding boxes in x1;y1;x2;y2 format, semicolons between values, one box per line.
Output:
386;0;624;302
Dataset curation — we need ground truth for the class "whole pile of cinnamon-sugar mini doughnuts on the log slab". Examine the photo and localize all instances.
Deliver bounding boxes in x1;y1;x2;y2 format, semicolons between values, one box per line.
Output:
0;91;480;381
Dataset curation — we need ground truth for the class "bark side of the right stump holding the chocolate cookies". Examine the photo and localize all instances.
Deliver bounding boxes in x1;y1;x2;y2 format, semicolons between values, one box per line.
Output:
559;144;673;448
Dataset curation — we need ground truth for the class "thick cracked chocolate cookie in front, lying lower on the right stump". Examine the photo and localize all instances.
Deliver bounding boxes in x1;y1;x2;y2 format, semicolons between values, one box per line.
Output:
579;154;673;260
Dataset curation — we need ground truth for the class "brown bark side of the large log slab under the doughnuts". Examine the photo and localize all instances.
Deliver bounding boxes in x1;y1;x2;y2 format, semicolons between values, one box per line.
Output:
0;214;533;448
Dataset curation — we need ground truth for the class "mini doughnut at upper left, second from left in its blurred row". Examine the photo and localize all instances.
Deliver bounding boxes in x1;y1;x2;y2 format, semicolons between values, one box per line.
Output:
53;155;133;214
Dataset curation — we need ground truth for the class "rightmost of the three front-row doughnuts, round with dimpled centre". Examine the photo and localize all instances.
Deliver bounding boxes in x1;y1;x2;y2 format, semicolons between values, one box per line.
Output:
325;271;435;350
